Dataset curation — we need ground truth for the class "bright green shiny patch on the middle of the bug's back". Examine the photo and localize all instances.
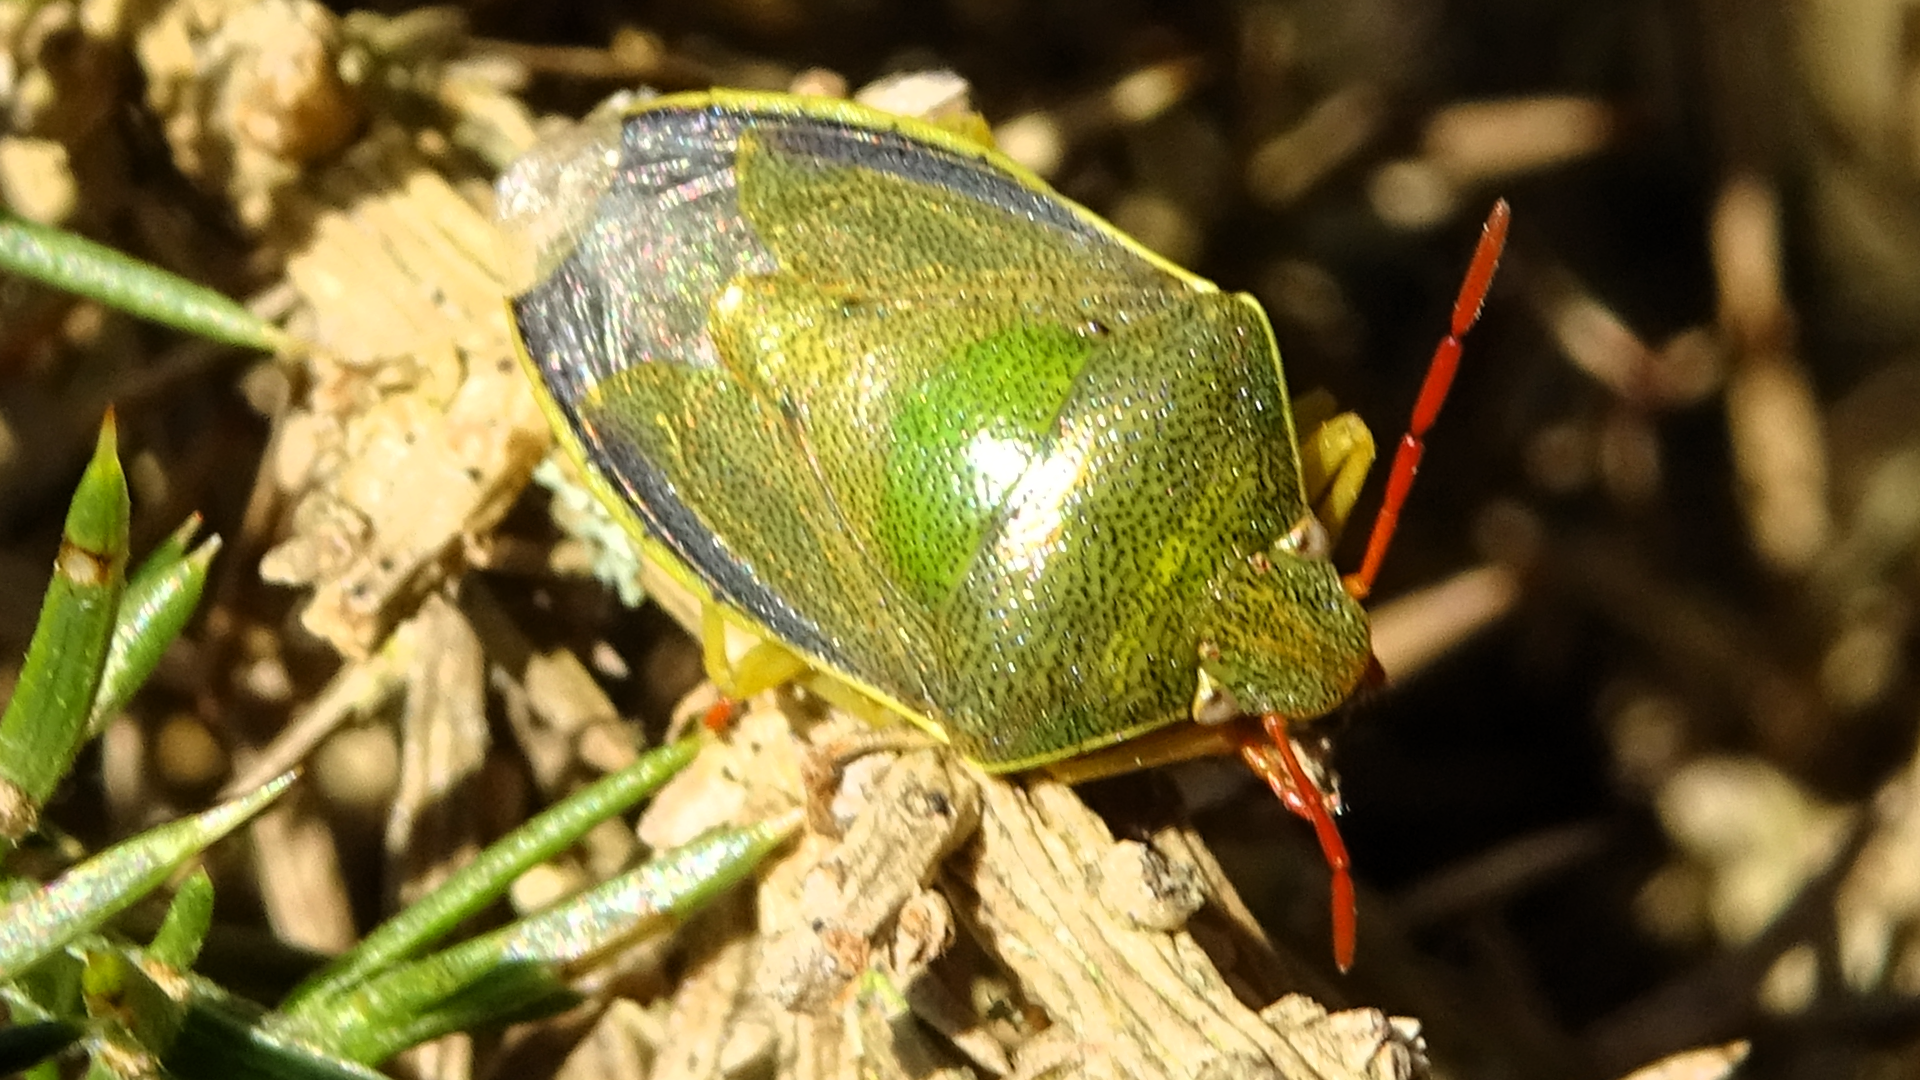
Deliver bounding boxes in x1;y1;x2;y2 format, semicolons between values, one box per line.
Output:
874;325;1092;607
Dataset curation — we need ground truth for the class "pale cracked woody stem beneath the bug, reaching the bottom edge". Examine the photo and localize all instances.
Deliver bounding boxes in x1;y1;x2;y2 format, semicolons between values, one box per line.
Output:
622;696;1425;1080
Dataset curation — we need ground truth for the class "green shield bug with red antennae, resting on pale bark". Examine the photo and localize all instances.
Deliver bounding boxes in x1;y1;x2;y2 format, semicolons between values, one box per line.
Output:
501;90;1507;969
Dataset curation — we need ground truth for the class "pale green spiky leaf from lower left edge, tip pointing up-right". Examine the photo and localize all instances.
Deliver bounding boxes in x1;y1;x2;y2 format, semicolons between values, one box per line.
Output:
0;773;294;978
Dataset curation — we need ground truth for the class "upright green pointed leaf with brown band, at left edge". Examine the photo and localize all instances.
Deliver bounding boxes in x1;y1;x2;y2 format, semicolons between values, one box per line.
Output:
0;413;131;844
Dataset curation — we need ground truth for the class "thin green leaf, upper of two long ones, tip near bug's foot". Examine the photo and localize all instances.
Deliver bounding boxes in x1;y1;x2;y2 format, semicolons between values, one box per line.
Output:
282;736;701;1017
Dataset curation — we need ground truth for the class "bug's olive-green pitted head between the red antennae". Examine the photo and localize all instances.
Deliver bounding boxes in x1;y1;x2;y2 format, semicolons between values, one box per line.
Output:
1194;513;1373;724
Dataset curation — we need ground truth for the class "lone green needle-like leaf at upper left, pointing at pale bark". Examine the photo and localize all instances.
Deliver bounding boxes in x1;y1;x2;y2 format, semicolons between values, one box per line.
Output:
0;213;294;352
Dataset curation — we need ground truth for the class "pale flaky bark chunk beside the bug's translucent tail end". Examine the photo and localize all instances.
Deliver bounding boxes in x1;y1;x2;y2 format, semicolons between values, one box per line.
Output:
261;129;551;655
